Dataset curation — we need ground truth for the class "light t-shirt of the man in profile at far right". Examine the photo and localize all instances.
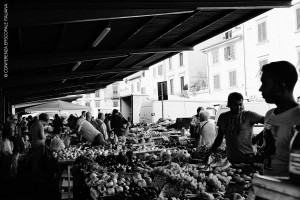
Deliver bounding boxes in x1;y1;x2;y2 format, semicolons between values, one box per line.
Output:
264;105;300;176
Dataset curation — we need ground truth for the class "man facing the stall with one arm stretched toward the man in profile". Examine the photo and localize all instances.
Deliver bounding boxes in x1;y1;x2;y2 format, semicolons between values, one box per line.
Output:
207;92;264;164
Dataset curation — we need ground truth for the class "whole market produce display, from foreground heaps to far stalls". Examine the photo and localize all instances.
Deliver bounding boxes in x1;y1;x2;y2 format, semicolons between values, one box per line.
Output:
53;124;264;200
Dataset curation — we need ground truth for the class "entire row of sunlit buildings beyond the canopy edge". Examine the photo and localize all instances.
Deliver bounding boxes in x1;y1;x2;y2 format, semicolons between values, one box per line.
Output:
77;0;300;117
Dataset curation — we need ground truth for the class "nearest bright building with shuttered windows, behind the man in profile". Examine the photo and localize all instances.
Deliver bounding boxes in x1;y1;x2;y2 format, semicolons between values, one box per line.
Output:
196;0;300;99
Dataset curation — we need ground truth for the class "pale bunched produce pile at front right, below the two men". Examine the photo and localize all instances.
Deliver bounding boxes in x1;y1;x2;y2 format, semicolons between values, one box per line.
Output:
152;163;252;199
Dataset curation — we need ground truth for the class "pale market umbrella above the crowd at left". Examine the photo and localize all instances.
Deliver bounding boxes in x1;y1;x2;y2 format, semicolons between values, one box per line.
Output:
25;100;91;112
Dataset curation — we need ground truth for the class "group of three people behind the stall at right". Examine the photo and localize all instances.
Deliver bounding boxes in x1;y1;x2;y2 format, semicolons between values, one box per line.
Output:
191;61;300;176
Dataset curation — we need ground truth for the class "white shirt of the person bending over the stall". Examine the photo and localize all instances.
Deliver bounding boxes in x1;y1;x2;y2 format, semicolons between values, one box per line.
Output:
76;118;100;142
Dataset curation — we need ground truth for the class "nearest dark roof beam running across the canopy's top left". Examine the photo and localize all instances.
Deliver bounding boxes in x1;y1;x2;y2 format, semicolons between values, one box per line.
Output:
9;8;197;27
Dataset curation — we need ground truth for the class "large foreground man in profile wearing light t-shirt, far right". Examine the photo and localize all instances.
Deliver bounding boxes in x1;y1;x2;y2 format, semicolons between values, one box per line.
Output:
259;61;300;176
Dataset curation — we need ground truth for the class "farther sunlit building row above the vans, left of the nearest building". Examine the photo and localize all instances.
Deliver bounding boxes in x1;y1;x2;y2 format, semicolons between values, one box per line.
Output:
120;51;208;99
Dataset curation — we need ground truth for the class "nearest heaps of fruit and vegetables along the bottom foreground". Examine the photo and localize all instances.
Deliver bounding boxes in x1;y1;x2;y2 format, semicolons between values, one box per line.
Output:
71;150;253;199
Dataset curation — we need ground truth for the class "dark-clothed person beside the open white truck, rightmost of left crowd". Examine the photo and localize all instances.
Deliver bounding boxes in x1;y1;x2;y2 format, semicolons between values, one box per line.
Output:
110;109;128;136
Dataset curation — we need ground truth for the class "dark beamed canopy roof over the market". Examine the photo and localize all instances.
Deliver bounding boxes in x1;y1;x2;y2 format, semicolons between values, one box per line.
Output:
0;0;291;104
